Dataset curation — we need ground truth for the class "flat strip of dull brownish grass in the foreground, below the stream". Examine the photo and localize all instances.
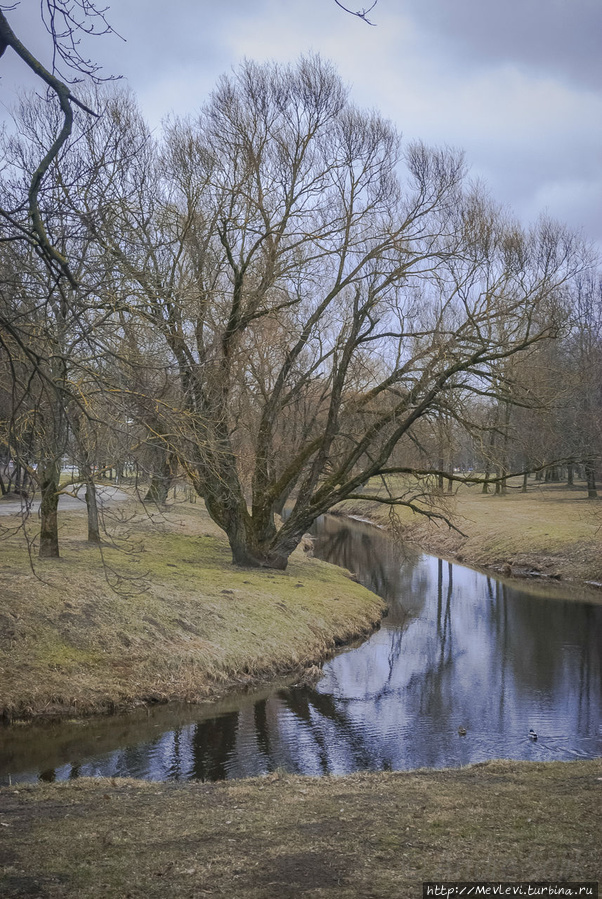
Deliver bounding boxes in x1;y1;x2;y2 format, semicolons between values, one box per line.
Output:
0;760;602;899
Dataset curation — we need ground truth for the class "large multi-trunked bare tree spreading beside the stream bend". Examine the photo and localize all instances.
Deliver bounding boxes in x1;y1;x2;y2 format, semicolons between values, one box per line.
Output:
62;58;582;568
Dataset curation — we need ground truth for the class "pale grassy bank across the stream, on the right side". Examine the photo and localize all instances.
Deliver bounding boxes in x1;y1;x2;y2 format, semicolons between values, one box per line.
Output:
338;479;602;602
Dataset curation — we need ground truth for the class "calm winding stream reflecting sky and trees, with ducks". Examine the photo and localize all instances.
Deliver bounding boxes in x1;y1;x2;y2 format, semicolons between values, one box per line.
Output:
0;518;602;784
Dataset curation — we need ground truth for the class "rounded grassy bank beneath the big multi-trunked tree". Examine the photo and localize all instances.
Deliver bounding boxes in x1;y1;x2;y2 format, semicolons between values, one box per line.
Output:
0;504;383;718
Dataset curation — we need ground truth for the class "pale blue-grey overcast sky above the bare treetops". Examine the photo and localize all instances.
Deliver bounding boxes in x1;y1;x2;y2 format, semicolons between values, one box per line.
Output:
0;0;602;245
